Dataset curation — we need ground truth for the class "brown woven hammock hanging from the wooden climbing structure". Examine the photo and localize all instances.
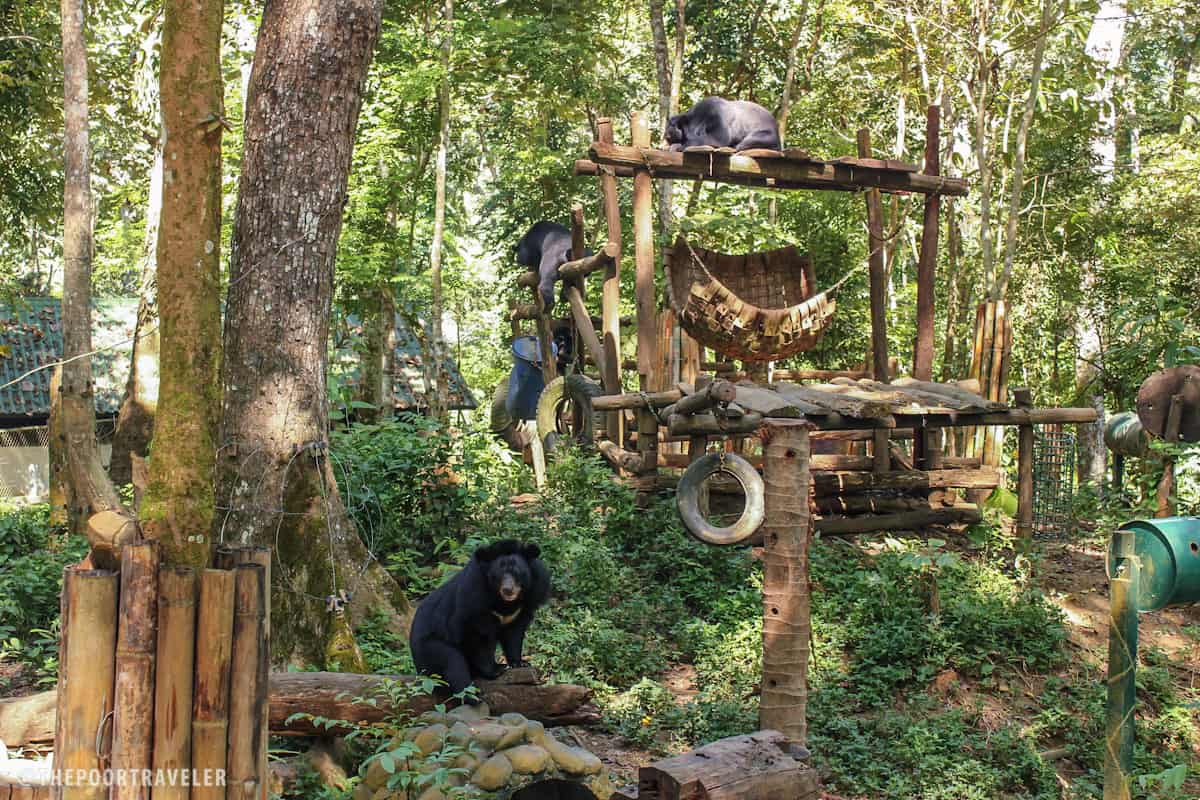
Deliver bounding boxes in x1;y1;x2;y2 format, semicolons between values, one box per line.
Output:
664;236;835;361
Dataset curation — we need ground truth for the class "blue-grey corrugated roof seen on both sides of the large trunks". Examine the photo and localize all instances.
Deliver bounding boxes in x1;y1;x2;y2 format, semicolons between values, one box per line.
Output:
0;297;476;426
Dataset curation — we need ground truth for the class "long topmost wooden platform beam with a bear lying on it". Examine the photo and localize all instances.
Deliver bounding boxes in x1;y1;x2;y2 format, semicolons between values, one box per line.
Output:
588;142;967;196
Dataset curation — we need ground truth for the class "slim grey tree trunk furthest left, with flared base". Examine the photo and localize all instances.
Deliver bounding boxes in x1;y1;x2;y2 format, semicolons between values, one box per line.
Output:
57;0;120;534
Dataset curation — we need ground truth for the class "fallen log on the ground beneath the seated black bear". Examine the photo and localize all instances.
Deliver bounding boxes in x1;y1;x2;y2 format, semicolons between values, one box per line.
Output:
0;668;600;747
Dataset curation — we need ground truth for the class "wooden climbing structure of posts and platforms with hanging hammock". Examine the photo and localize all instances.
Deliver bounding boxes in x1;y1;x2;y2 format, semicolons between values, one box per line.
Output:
504;107;1097;786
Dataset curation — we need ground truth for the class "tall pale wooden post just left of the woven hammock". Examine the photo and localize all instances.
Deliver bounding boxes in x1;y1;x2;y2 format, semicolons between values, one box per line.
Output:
630;112;659;474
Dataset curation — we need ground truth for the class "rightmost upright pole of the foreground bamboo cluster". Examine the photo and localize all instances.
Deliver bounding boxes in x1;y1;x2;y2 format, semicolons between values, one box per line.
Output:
226;563;268;800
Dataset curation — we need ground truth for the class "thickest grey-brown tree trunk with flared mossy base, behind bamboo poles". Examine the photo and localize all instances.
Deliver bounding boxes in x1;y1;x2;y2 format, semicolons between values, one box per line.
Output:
215;0;408;663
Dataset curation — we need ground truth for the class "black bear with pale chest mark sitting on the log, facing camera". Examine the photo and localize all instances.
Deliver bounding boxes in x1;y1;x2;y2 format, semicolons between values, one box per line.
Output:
408;539;550;694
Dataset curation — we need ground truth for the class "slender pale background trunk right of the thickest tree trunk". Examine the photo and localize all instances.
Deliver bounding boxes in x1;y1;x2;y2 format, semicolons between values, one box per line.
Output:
426;0;454;422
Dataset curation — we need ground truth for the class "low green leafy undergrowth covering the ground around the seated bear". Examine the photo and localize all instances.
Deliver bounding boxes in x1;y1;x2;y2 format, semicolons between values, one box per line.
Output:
0;420;1200;800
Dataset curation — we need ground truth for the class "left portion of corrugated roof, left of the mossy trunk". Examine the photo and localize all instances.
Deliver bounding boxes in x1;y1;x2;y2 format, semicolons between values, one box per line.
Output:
0;297;138;422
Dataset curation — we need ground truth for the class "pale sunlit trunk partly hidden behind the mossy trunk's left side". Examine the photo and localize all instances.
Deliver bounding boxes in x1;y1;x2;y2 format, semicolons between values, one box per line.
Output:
108;136;162;486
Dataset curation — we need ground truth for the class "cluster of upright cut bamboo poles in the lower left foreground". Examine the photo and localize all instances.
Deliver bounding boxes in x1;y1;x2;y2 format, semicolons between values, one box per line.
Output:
54;541;270;800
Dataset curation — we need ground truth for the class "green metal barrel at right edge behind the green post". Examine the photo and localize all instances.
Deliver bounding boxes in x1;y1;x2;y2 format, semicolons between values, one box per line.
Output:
1109;517;1200;612
